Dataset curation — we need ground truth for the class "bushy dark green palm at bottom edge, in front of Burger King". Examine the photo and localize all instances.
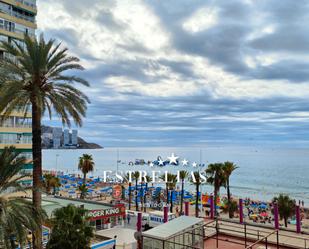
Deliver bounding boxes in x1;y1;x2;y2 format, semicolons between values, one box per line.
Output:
46;204;94;249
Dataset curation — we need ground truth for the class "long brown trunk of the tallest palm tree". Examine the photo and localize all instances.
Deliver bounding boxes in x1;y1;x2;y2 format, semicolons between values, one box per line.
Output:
32;99;42;249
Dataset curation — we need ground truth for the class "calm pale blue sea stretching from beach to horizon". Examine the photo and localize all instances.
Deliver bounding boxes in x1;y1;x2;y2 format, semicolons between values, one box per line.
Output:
43;146;309;206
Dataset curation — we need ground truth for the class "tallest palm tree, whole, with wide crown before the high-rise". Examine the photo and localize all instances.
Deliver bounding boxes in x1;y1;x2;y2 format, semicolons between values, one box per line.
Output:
0;35;89;249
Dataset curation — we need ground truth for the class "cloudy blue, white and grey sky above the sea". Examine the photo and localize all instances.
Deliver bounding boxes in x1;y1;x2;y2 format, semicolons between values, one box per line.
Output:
37;0;309;146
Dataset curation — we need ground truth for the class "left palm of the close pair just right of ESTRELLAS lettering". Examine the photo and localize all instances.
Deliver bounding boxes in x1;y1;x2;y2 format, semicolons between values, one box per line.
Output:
205;163;226;215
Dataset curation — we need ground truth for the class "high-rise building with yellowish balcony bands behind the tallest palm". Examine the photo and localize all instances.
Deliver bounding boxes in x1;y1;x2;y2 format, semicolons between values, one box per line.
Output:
0;0;37;169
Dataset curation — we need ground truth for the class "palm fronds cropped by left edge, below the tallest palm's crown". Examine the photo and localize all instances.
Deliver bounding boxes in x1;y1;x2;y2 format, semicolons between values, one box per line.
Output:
0;147;46;249
